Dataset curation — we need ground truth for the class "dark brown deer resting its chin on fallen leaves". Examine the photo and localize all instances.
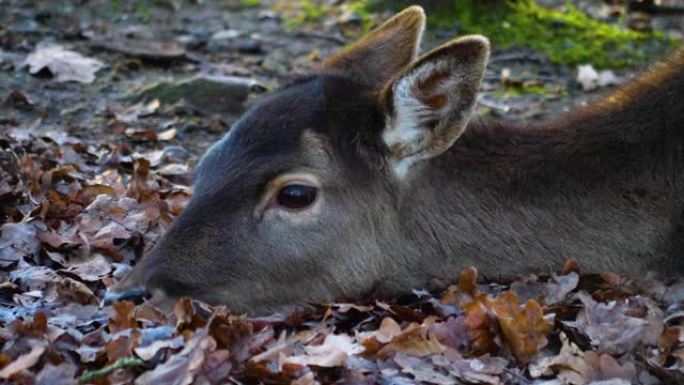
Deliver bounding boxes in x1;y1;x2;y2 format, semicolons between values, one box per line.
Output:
106;6;684;314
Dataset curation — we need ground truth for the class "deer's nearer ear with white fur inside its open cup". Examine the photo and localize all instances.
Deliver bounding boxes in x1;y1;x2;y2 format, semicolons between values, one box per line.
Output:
380;35;489;178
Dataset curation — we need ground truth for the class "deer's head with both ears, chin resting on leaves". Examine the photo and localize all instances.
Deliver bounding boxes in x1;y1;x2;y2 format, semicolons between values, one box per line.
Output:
109;6;489;312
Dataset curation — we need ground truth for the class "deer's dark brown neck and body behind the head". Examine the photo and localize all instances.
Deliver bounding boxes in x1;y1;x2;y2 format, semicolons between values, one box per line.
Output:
376;52;684;289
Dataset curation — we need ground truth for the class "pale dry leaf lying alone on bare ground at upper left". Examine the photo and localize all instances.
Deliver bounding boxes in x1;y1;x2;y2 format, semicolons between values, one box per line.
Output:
24;45;104;84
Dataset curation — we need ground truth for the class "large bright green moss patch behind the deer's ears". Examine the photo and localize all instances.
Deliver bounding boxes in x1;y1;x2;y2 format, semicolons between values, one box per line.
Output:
366;0;675;68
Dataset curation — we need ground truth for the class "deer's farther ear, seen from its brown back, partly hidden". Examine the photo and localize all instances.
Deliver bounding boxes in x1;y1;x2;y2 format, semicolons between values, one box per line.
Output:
323;5;425;88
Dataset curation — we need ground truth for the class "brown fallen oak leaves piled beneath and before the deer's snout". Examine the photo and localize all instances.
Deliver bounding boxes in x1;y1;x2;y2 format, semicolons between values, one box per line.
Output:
0;129;684;385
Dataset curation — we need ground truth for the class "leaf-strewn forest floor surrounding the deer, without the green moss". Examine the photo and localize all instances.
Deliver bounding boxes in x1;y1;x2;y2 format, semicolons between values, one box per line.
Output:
0;0;684;384
